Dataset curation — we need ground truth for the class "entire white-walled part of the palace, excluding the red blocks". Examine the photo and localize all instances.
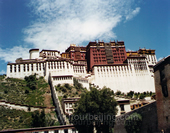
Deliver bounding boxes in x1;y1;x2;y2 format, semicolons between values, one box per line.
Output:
7;47;156;92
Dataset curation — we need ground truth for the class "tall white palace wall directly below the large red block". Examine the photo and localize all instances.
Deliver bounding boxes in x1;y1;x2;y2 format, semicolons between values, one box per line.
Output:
92;65;155;92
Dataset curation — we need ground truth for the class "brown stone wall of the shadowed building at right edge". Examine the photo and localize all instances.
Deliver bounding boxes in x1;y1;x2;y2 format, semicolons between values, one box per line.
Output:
155;64;170;131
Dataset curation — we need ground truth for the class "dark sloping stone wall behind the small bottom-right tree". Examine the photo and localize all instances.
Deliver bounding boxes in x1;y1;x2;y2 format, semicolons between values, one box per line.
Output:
114;102;158;133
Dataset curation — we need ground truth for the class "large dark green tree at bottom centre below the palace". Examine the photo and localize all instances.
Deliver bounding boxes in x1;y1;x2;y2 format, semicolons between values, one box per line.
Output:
71;87;117;133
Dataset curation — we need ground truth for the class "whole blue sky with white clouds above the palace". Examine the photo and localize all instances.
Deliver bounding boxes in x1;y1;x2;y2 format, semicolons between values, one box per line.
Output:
0;0;170;74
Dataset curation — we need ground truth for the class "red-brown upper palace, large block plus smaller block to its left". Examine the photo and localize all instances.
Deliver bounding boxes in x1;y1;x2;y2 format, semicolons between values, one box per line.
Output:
62;41;127;72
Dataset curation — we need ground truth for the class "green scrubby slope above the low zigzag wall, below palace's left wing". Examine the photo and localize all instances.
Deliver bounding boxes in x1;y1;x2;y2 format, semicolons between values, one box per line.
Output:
0;75;49;106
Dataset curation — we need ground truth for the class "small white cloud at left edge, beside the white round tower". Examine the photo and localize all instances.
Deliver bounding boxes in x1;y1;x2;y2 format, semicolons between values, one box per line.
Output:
0;46;29;62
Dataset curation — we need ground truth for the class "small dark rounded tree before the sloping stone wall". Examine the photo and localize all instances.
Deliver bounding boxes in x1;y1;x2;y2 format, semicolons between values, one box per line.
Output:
125;113;142;133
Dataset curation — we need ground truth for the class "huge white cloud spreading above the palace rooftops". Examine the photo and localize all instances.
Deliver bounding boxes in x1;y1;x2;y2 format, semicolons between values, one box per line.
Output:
24;0;140;52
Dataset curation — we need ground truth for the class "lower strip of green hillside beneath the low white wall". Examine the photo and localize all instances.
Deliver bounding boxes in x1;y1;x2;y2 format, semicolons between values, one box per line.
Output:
0;106;59;130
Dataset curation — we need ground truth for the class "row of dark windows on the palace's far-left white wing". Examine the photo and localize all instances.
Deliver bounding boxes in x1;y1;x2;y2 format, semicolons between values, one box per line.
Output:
10;63;44;73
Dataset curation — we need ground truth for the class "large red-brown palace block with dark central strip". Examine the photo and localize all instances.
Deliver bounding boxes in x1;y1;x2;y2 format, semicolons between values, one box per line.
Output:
86;41;127;71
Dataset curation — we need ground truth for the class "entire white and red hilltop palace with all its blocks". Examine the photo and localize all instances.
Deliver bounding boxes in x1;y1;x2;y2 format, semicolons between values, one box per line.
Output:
7;41;157;92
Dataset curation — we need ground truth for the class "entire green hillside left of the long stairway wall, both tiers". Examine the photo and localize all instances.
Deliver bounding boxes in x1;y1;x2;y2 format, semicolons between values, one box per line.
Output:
0;75;59;130
